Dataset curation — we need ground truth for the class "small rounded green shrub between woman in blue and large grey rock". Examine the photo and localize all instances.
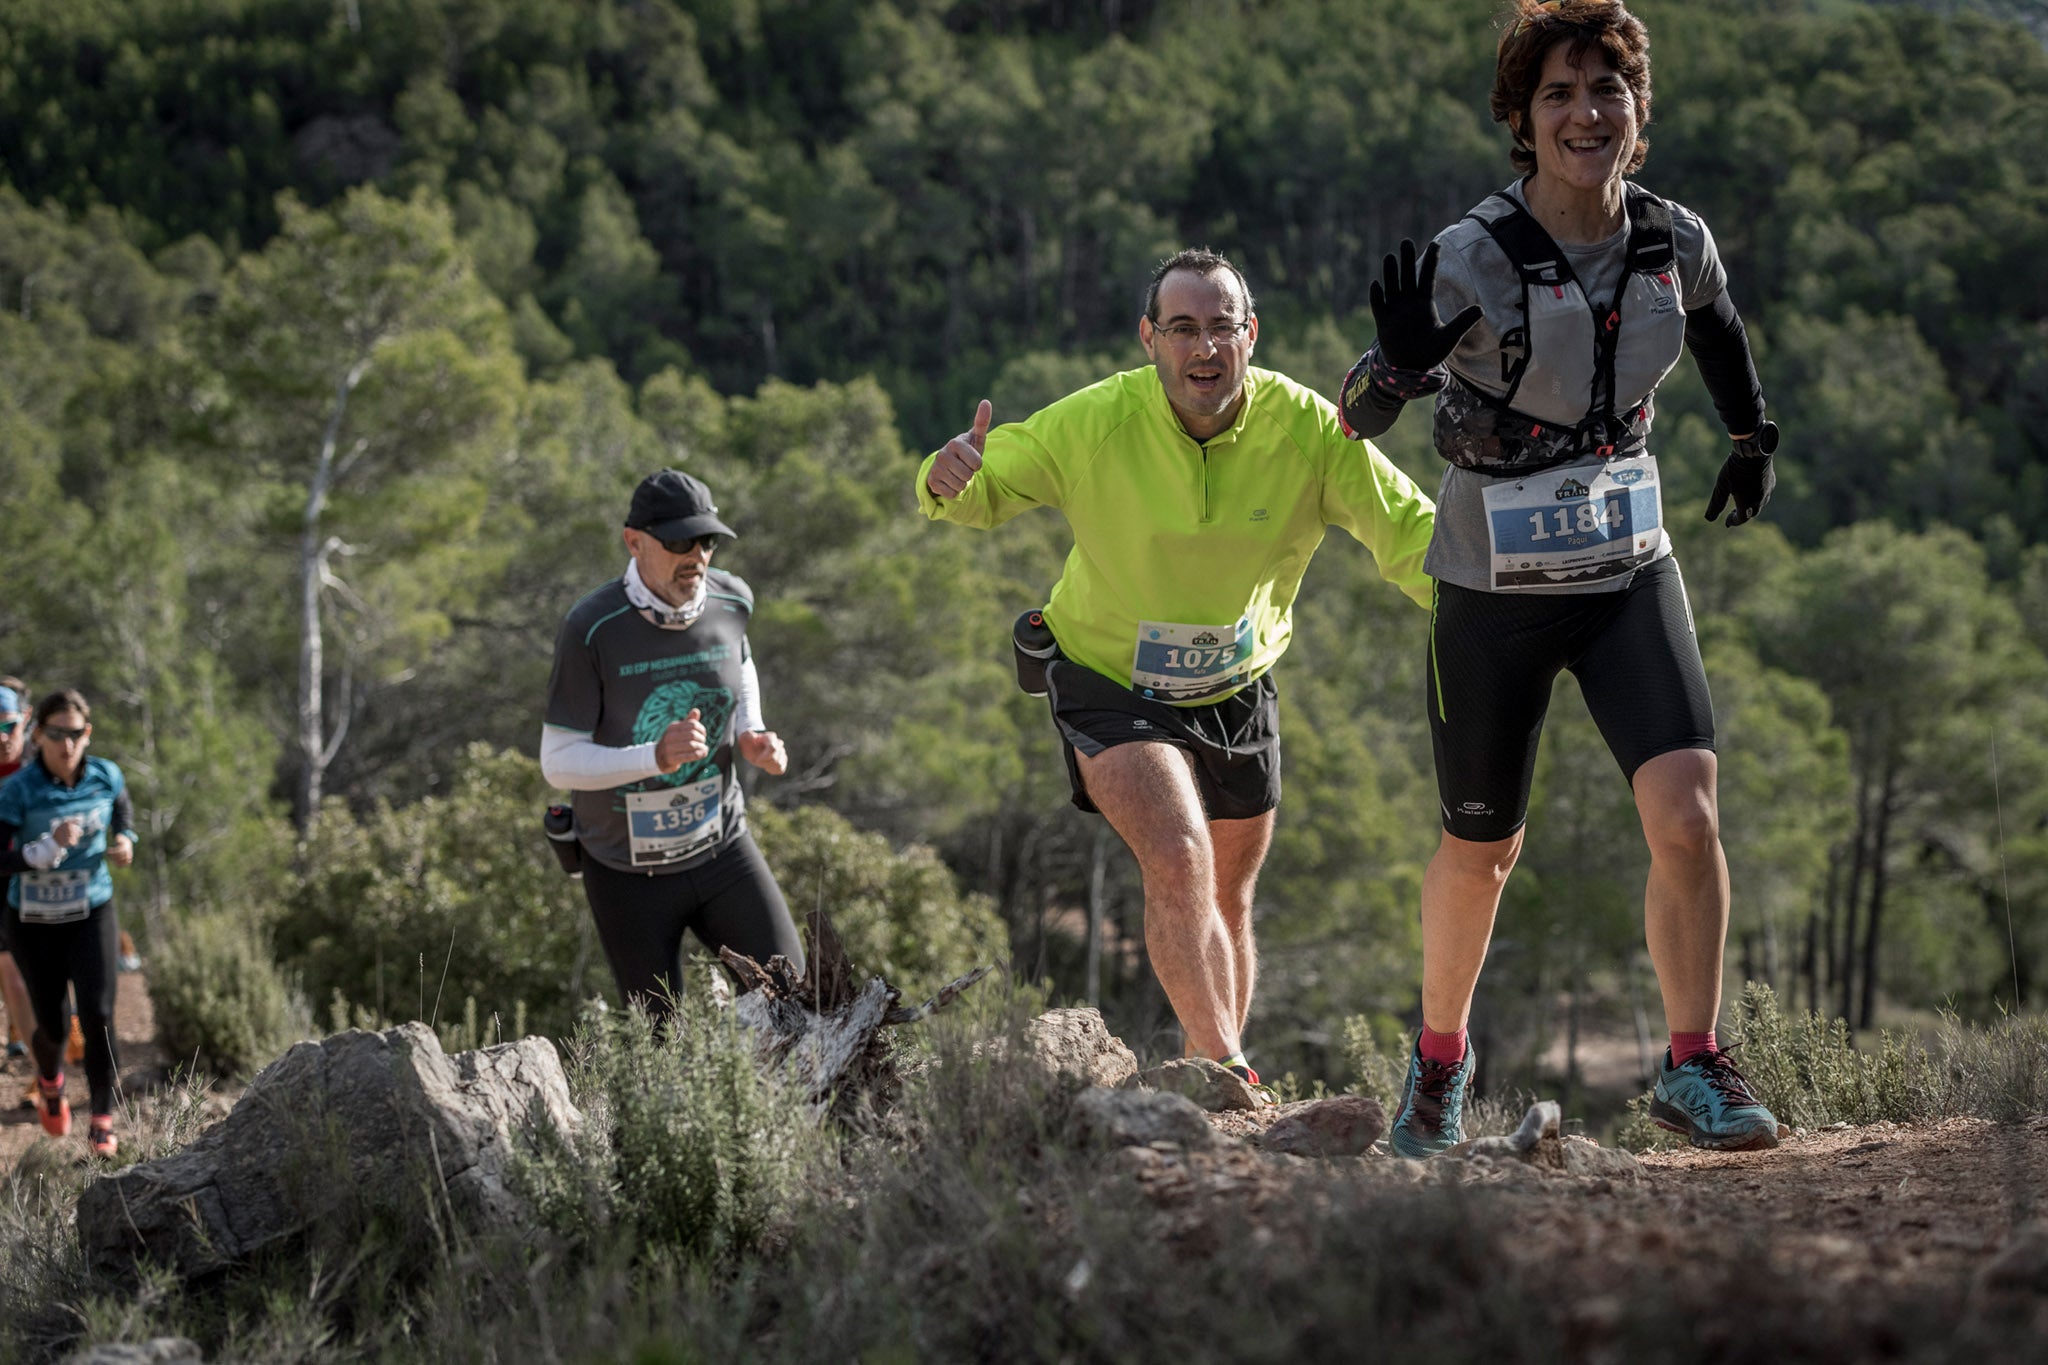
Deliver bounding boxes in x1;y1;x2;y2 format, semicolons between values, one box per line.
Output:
150;911;311;1076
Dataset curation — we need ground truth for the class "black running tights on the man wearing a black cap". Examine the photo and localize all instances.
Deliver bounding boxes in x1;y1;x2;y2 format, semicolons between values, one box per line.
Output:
584;831;803;1017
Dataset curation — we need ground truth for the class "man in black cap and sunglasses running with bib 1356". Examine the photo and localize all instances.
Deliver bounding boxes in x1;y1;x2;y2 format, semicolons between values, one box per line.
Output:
541;469;803;1017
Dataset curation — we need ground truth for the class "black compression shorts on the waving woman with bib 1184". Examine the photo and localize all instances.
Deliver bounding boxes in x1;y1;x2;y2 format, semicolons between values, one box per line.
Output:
1427;557;1714;843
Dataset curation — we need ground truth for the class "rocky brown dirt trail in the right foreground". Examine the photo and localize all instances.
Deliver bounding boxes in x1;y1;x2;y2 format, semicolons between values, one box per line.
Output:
1155;1113;2048;1365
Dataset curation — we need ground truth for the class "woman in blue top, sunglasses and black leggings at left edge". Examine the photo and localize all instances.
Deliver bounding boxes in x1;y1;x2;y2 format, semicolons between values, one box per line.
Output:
0;688;135;1156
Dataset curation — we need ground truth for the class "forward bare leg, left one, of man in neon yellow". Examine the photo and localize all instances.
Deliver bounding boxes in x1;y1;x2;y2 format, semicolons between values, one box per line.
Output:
1075;743;1249;1058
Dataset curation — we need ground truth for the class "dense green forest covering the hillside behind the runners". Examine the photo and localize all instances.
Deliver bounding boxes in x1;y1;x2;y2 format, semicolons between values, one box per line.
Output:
0;0;2048;1074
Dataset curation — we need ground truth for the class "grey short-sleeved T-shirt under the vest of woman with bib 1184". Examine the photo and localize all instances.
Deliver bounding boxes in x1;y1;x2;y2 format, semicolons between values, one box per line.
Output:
1423;182;1726;593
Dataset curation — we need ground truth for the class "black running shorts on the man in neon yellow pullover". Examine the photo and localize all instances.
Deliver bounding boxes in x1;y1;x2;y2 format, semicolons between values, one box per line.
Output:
1044;659;1280;821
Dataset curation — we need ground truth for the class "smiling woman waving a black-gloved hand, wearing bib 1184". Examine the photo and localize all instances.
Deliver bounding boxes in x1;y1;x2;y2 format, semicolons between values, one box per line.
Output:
1343;0;1778;1156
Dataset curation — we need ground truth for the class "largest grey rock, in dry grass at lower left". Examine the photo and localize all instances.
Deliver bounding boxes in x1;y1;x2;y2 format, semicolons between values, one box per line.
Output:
78;1023;582;1277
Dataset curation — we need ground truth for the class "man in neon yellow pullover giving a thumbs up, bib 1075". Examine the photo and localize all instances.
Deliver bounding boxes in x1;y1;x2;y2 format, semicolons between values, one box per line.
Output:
918;250;1436;1083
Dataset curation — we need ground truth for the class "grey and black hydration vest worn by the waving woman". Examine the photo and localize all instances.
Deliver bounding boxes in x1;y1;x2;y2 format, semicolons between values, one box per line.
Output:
1436;182;1686;475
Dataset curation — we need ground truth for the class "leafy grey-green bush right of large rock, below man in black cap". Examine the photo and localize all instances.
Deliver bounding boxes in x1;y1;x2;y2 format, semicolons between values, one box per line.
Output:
518;995;829;1261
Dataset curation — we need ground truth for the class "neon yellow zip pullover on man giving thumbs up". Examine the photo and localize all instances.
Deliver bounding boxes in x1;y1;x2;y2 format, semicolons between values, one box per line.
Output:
918;366;1436;704
